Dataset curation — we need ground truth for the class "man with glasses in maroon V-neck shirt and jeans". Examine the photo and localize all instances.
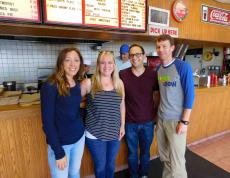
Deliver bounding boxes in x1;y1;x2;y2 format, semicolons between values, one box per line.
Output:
120;44;158;178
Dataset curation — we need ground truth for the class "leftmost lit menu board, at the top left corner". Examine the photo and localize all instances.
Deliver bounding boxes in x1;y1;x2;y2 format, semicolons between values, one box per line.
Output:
0;0;40;22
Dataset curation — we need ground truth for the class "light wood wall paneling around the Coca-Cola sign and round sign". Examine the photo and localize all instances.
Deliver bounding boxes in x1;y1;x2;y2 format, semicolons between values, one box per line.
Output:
148;0;230;43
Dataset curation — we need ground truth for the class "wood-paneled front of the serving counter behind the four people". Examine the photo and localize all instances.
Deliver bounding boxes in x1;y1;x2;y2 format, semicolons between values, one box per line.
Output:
0;87;230;178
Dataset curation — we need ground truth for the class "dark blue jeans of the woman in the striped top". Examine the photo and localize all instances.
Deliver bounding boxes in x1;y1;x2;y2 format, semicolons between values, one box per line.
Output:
86;137;120;178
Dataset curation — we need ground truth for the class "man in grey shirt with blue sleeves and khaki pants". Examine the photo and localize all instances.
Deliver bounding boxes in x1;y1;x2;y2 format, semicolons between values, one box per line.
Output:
156;35;194;178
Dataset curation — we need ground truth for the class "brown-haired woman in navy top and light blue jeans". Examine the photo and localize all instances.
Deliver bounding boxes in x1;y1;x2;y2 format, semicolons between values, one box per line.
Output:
41;48;85;178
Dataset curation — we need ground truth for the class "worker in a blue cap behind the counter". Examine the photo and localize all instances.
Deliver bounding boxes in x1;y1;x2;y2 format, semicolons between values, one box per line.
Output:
116;44;131;71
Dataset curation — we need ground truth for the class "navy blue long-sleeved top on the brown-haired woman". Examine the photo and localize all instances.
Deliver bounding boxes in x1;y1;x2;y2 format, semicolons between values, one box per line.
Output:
41;82;85;160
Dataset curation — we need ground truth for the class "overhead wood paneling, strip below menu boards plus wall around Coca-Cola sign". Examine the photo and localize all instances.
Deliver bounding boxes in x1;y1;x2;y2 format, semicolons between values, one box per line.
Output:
0;0;230;47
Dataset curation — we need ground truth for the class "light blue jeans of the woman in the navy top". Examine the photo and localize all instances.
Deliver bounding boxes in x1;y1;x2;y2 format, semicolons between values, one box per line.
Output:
48;134;85;178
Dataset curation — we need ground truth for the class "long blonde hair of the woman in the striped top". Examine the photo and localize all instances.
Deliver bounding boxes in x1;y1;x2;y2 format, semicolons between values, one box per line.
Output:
91;51;123;98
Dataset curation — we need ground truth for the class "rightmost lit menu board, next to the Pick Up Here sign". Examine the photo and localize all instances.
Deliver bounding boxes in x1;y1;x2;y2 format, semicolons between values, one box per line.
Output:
121;0;146;31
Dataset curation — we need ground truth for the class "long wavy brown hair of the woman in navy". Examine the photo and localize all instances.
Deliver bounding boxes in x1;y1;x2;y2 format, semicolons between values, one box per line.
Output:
48;48;84;96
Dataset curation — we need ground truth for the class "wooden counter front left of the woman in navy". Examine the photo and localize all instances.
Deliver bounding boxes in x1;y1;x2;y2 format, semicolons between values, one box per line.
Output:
0;108;49;178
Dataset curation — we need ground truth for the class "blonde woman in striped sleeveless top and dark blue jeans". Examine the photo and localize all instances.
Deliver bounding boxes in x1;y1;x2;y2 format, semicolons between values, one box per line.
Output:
81;51;125;178
